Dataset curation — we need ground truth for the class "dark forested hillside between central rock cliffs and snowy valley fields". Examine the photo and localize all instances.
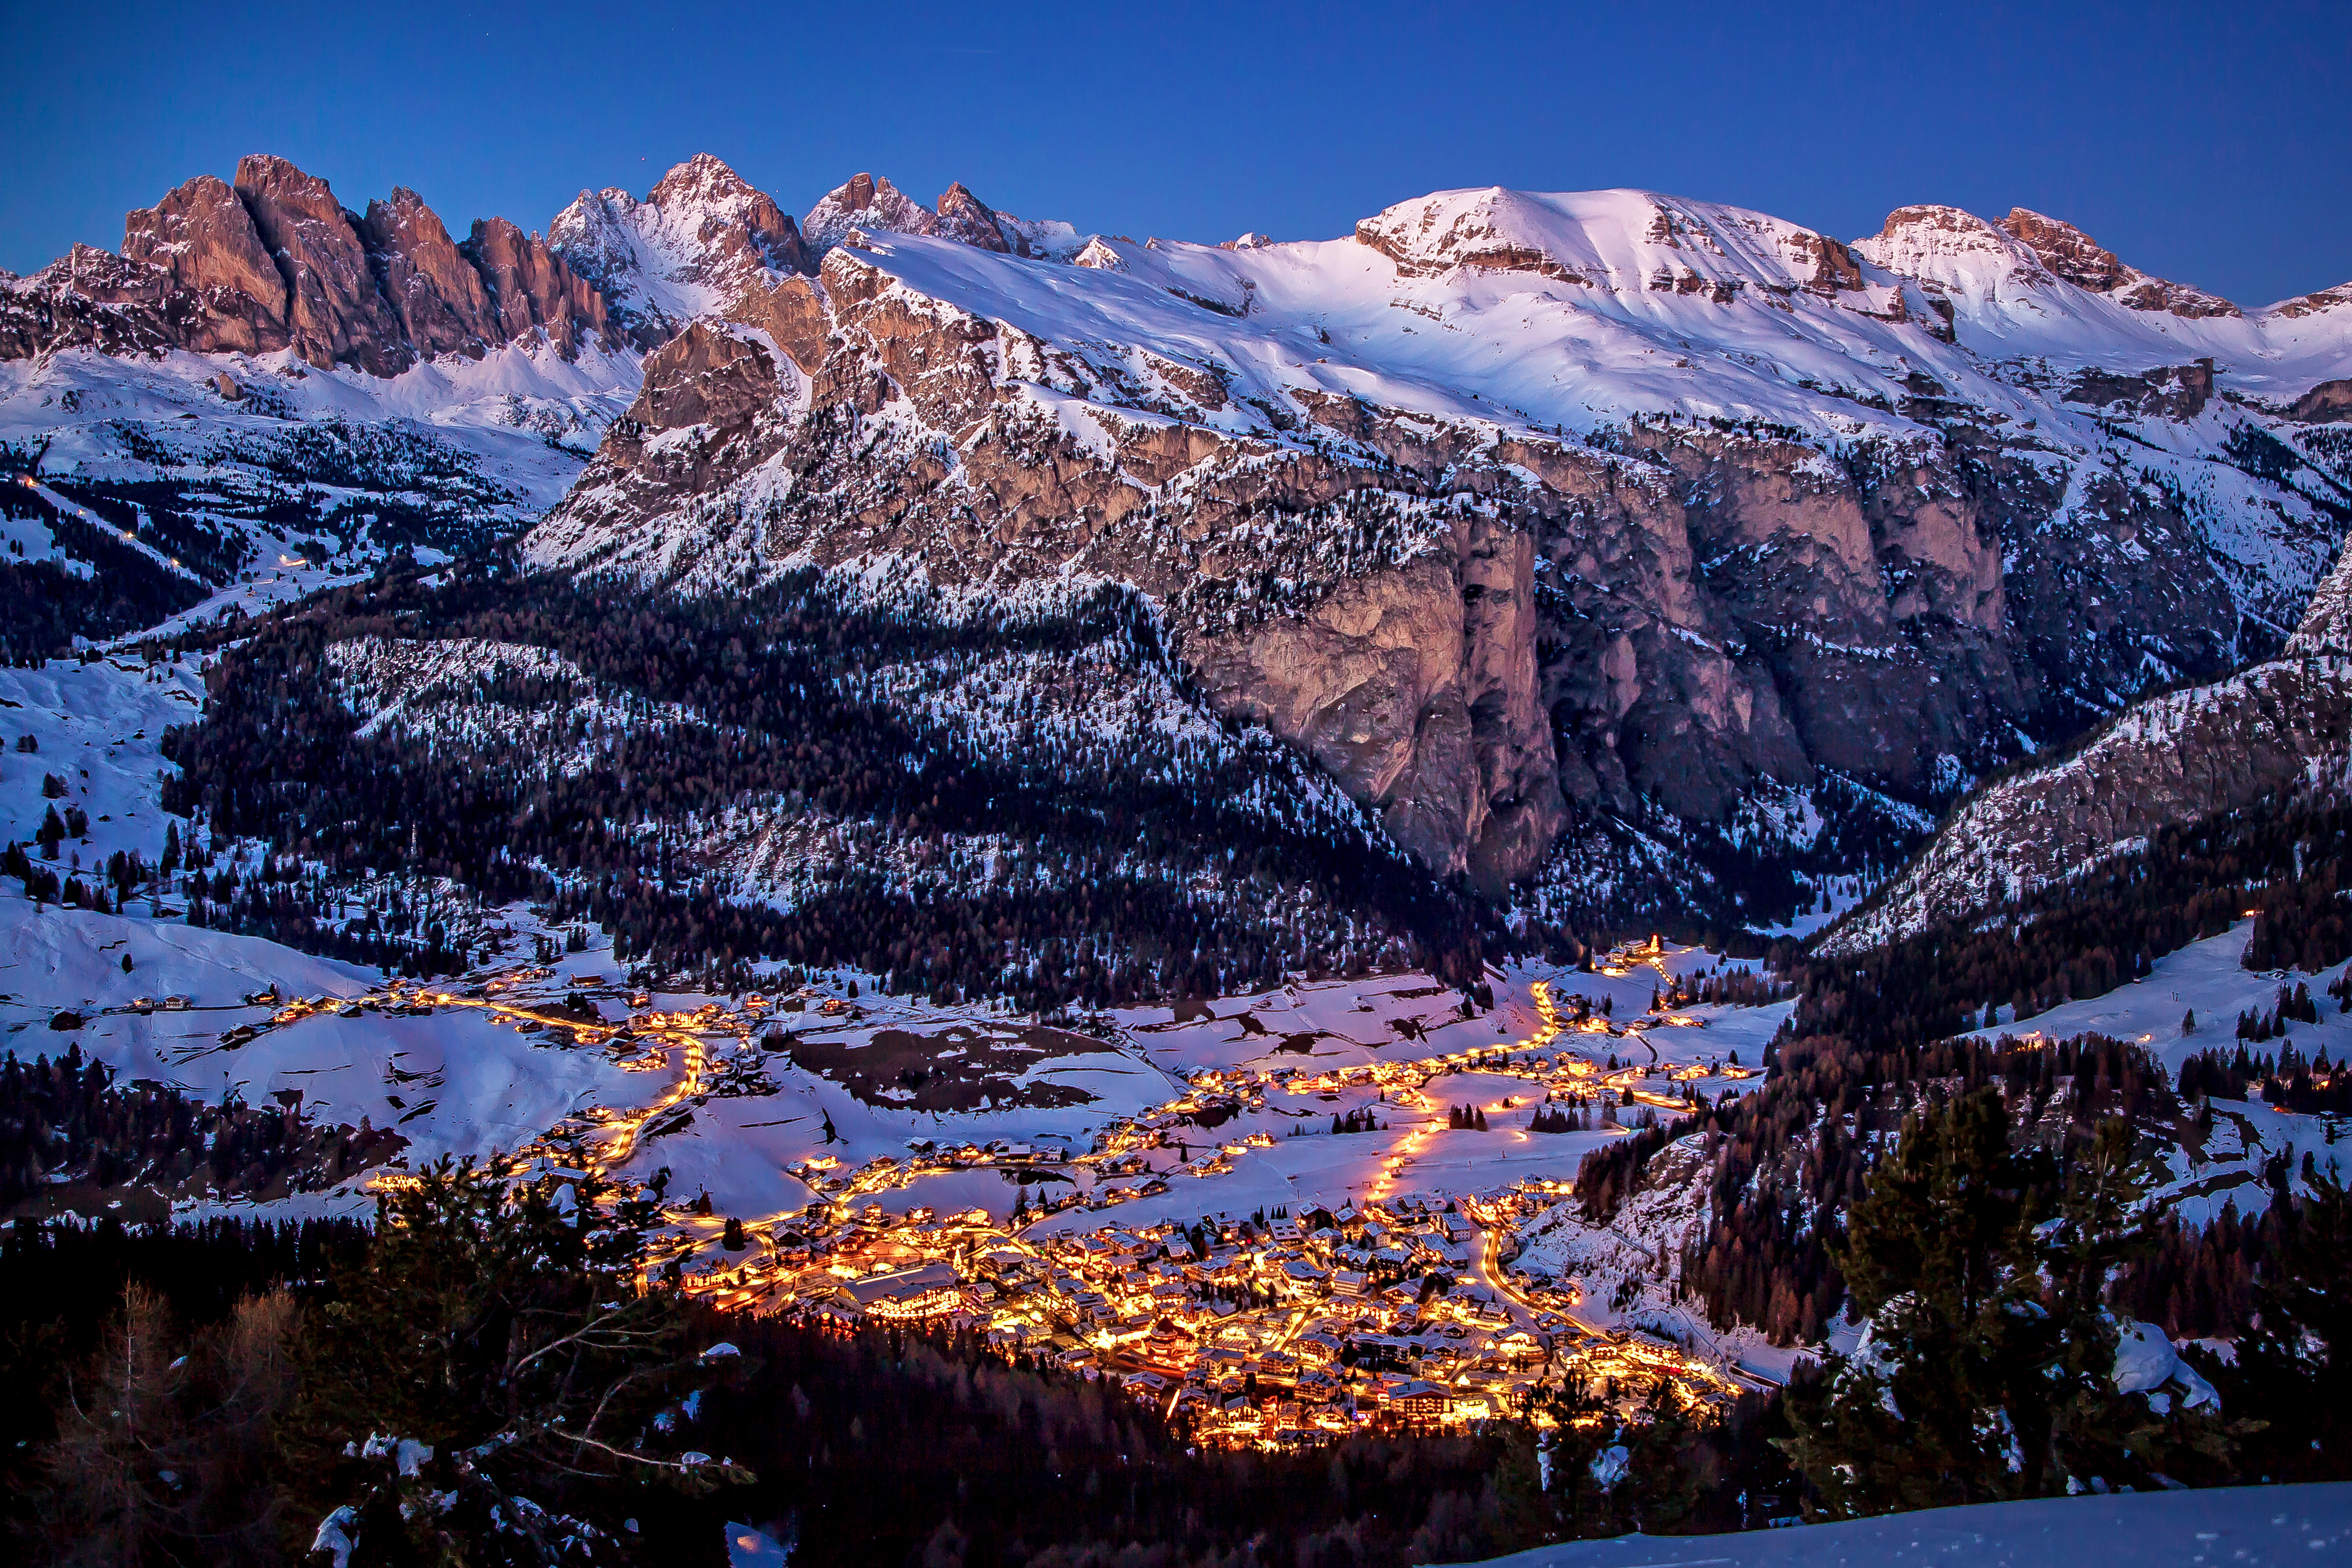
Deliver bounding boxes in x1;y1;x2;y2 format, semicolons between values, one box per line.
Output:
167;571;1493;1011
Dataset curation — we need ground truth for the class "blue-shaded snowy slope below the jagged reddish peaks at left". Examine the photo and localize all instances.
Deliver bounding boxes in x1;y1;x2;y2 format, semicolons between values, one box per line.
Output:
0;341;637;647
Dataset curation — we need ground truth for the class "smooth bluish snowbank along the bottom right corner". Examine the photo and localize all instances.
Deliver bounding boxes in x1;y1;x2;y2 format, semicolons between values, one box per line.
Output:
1489;1481;2352;1568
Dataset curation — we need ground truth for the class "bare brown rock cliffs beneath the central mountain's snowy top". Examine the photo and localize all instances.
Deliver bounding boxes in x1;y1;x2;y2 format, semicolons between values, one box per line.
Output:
531;237;2220;889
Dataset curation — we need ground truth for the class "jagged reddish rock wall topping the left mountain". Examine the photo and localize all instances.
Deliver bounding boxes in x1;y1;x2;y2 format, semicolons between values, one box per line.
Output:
0;155;609;376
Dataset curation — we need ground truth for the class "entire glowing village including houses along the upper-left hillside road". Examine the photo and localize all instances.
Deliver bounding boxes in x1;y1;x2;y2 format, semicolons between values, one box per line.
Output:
183;926;1759;1446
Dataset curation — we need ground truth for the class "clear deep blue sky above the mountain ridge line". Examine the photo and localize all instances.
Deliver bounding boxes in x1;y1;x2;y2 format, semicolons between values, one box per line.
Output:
0;0;2352;306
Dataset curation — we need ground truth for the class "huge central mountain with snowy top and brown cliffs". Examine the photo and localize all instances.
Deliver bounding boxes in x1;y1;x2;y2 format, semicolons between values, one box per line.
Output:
529;181;2352;910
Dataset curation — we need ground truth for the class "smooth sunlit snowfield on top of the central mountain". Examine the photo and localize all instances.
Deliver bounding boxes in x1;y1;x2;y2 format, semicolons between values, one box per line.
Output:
814;191;2352;444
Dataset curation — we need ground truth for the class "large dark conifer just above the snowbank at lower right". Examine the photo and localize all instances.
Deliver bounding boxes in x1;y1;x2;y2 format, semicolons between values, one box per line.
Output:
1783;1086;2246;1516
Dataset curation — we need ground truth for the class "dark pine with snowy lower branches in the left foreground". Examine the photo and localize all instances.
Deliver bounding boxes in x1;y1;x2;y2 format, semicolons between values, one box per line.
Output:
289;1159;743;1563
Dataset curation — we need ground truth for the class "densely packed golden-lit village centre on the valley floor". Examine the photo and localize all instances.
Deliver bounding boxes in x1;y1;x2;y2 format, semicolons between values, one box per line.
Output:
635;945;1755;1446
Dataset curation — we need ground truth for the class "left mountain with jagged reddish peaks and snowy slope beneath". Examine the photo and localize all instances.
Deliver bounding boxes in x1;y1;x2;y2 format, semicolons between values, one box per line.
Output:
0;157;637;653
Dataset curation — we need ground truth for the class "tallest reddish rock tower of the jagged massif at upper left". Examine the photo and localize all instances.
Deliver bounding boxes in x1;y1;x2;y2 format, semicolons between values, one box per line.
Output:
235;153;416;376
